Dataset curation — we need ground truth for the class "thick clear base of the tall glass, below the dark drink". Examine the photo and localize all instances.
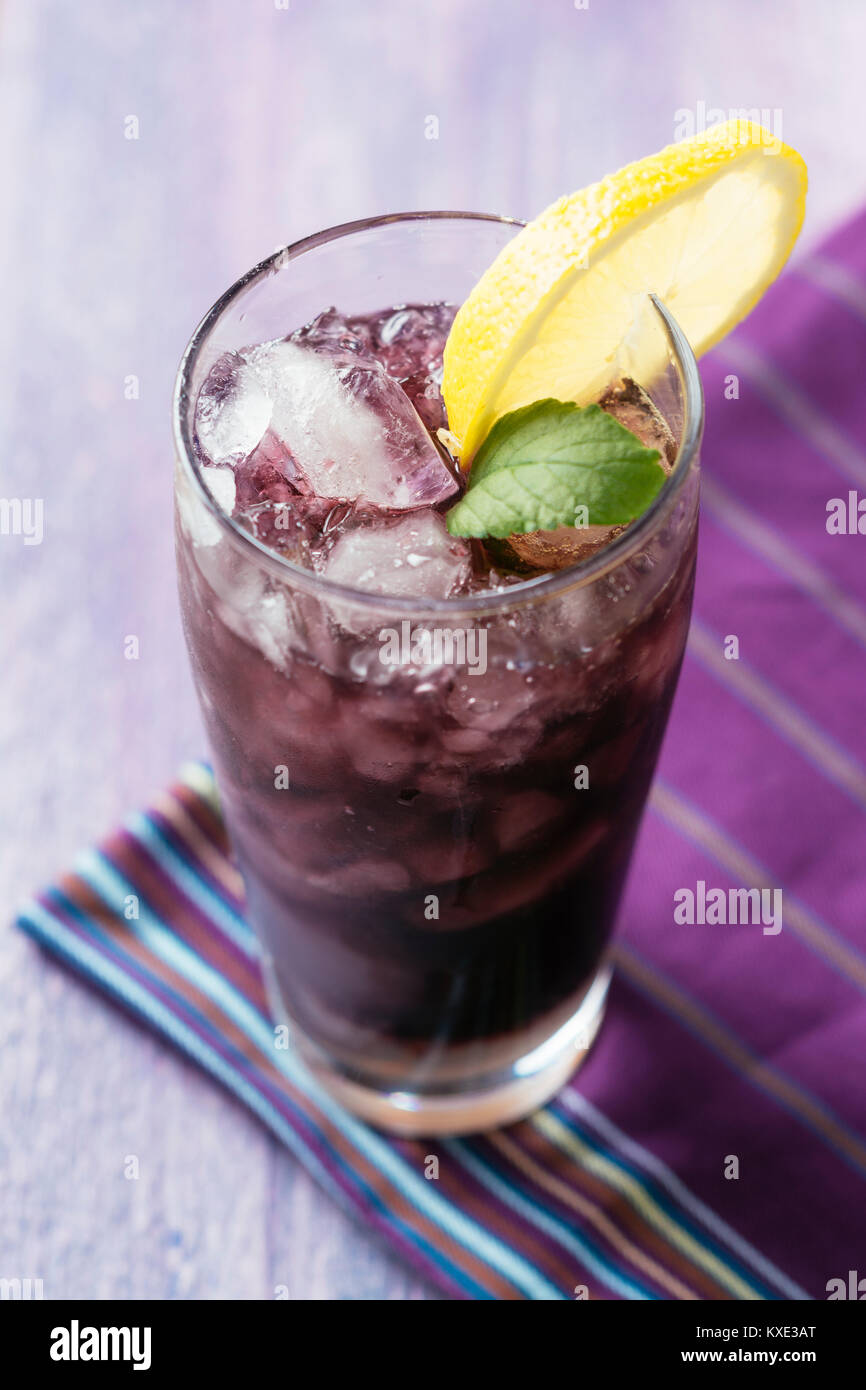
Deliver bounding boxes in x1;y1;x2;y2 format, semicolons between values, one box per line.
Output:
265;963;612;1138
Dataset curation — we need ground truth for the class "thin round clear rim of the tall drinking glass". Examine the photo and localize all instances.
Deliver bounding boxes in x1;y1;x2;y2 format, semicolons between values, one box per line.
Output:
172;211;703;617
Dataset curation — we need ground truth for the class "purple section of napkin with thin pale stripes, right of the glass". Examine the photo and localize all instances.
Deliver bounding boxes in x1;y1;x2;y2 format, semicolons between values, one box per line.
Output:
603;205;866;1298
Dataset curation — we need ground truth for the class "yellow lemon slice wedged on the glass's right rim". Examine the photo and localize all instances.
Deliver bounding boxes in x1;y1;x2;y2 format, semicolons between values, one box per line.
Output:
442;121;806;464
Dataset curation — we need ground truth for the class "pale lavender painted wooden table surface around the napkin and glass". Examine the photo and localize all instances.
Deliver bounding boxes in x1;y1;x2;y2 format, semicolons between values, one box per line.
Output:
0;0;866;1300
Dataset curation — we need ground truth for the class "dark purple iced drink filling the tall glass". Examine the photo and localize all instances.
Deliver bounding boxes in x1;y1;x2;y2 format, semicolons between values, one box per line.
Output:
178;214;695;1130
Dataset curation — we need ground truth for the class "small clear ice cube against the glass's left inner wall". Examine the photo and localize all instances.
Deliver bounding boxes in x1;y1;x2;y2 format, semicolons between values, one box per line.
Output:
196;353;271;464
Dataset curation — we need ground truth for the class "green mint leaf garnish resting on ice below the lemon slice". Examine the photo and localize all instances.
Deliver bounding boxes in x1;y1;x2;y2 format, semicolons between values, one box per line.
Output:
445;399;666;538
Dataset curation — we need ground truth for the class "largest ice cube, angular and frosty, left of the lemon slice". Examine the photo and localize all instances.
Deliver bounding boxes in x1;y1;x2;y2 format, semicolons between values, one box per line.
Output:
245;341;457;510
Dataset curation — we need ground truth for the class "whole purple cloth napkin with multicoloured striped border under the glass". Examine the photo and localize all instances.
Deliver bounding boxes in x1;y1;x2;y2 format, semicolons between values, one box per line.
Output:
19;217;866;1300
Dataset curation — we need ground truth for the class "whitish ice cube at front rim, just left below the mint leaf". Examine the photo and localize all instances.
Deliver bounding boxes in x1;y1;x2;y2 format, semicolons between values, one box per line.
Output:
322;512;470;599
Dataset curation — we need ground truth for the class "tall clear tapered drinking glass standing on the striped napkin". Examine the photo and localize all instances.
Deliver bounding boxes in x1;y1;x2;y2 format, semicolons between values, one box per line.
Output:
175;213;702;1133
